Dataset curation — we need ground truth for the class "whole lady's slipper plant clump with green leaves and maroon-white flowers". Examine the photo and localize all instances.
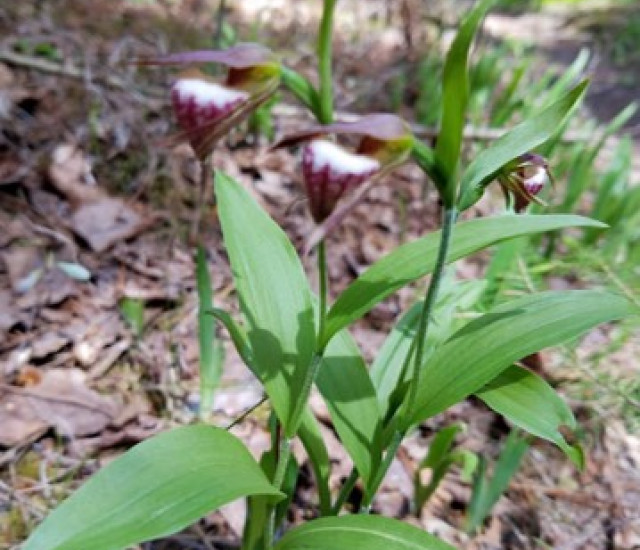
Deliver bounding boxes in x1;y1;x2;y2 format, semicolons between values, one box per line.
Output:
24;0;637;550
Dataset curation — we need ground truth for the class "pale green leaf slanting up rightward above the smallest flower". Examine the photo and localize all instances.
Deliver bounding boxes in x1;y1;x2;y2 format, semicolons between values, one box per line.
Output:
458;80;588;211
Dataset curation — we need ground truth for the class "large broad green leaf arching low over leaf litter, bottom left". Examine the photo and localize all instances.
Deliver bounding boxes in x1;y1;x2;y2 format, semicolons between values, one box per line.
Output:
23;425;280;550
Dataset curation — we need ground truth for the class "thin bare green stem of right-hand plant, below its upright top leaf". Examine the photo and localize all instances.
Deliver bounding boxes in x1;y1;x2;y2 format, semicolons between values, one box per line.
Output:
402;208;458;432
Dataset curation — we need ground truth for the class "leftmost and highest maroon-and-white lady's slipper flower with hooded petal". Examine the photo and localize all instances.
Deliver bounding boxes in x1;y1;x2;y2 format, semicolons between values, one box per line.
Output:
140;44;280;160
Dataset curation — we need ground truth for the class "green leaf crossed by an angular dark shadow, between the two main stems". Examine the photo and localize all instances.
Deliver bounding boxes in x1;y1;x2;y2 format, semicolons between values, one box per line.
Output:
316;331;381;483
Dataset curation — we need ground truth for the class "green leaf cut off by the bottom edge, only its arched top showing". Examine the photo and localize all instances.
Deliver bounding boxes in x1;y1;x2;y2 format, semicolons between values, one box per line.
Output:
273;515;453;550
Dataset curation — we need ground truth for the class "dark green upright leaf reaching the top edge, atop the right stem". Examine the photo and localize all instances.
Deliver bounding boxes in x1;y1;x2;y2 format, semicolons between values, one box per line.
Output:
436;0;494;206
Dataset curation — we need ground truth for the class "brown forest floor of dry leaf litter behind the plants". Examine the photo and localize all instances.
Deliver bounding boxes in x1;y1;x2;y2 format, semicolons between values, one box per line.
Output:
0;0;640;550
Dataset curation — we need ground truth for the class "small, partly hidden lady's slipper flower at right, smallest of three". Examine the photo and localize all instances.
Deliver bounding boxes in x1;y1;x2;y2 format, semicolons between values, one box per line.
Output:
498;153;551;212
